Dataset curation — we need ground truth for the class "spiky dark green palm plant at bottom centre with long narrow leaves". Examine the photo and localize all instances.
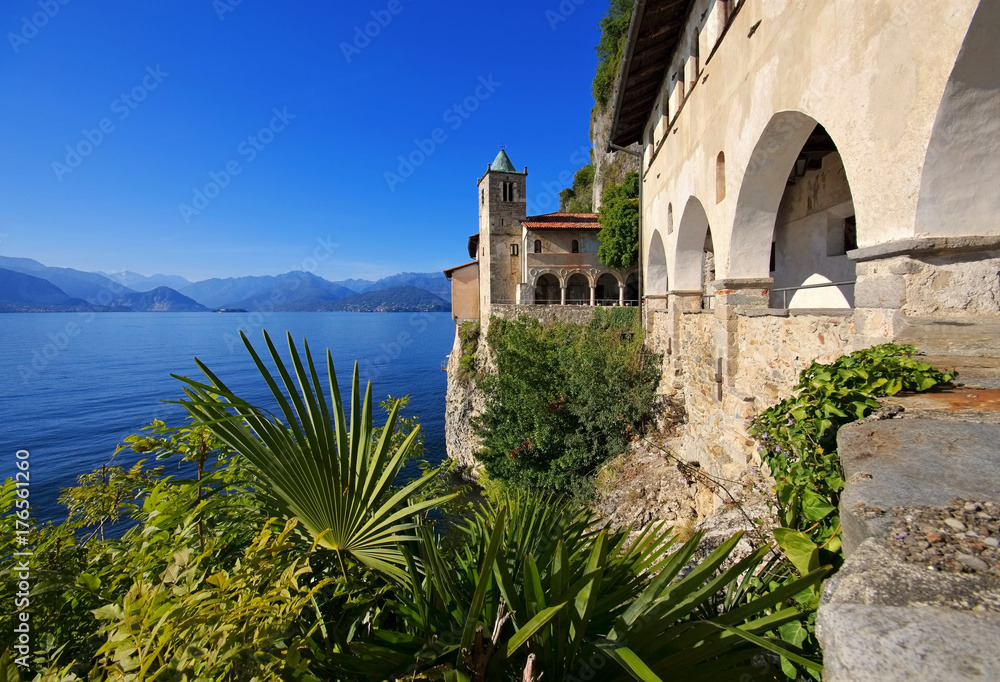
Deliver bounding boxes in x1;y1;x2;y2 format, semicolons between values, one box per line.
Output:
331;493;826;682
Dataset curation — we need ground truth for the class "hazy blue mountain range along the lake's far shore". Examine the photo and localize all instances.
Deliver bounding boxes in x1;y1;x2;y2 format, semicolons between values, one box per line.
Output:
0;256;451;312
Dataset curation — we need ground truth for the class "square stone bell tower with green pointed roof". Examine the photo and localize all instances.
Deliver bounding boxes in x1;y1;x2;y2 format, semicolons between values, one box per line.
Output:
478;147;528;317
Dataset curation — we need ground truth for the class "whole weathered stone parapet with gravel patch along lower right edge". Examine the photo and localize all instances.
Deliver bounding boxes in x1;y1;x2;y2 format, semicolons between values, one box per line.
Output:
818;320;1000;682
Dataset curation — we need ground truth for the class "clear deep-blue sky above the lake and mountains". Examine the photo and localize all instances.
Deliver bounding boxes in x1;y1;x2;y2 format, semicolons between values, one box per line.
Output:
0;0;607;280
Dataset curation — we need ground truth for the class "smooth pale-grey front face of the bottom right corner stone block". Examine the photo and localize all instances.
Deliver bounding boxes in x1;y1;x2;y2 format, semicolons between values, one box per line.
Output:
818;604;1000;682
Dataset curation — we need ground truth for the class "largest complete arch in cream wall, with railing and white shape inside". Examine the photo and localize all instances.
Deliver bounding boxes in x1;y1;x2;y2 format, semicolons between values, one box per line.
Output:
729;111;858;309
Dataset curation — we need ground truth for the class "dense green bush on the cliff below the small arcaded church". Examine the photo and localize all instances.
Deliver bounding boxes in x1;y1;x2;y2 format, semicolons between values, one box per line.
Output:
474;309;660;491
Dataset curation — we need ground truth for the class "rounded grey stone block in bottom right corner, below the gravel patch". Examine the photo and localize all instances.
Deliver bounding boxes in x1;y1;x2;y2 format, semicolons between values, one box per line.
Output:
817;538;1000;682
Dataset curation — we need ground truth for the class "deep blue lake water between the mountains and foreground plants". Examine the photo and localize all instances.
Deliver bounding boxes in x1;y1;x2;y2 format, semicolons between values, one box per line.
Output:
0;313;454;521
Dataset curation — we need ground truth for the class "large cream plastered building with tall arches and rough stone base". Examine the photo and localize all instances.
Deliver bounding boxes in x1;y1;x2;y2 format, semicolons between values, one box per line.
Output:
611;0;1000;475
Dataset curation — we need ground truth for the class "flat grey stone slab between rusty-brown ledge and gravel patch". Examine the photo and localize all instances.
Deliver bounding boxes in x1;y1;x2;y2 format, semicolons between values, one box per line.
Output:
837;419;1000;556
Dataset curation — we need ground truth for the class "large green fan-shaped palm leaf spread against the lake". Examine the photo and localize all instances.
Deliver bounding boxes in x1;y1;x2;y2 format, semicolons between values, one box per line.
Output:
175;332;453;580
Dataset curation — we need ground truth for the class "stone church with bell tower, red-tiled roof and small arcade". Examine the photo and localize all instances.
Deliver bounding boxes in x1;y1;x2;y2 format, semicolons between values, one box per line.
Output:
445;149;639;321
